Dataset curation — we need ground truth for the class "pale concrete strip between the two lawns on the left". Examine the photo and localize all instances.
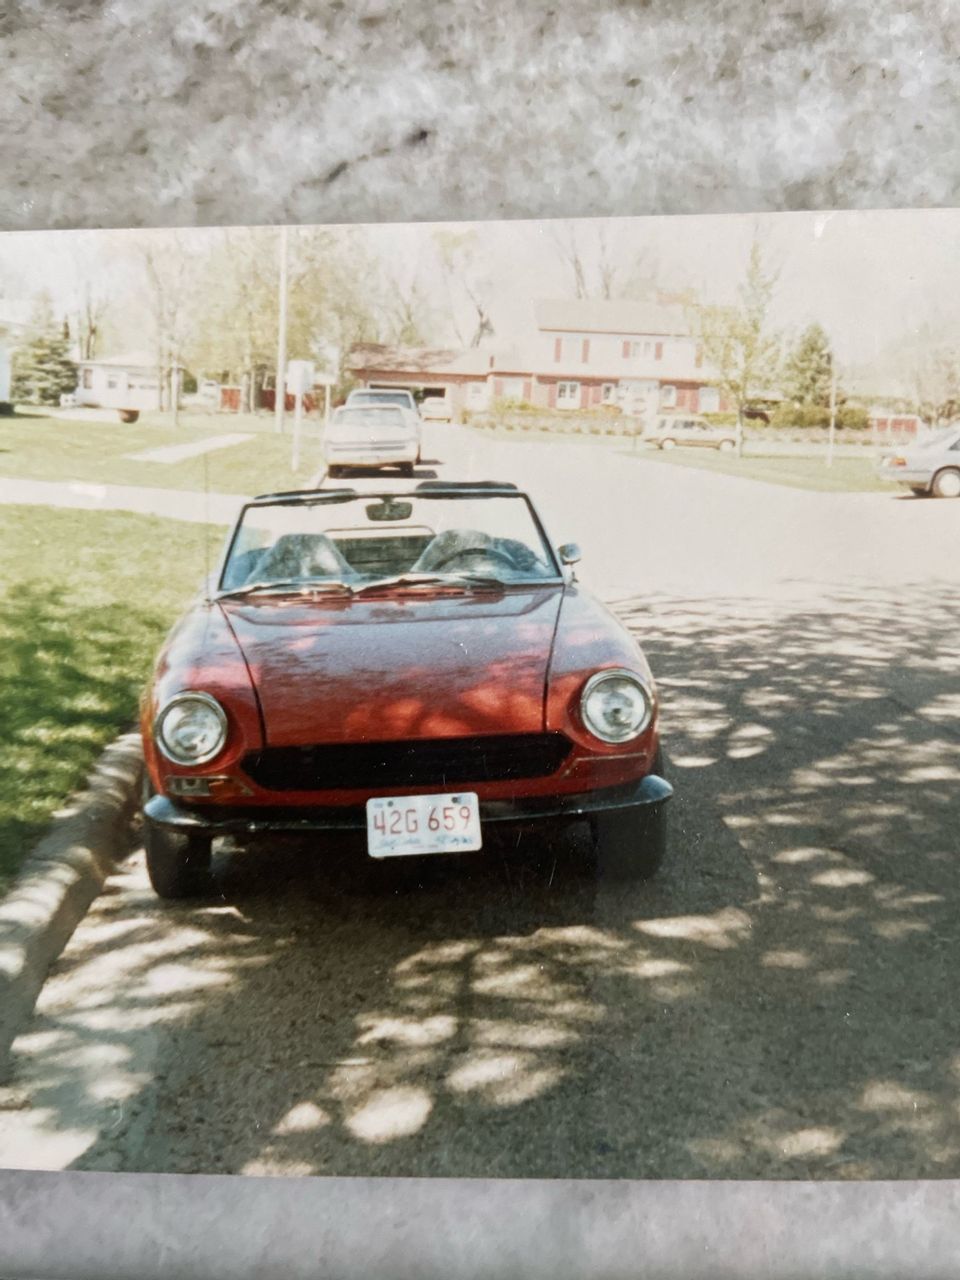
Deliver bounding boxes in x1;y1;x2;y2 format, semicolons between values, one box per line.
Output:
0;476;247;525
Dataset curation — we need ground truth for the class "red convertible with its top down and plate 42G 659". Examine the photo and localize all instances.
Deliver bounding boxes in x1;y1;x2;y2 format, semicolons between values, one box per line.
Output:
141;481;672;897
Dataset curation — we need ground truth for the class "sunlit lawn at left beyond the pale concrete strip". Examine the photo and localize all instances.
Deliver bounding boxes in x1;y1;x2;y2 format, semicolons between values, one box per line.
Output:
0;410;320;494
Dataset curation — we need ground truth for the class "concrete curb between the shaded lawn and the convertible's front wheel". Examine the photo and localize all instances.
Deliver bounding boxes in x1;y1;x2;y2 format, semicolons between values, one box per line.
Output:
0;733;143;1083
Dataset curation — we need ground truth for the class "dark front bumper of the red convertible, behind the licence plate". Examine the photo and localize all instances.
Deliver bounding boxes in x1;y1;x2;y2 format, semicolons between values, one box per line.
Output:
143;773;673;837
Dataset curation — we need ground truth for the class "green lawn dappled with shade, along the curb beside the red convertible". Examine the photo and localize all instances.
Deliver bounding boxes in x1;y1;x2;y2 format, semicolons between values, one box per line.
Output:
0;507;224;892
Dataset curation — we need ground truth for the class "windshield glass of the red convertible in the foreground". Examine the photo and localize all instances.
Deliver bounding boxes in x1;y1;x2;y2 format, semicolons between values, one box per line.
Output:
219;492;561;591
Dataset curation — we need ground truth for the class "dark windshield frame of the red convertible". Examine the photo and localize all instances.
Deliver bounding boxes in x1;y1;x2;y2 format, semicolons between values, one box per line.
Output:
212;481;567;599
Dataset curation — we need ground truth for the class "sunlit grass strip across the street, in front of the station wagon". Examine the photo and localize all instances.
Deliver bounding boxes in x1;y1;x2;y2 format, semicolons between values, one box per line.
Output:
625;448;893;493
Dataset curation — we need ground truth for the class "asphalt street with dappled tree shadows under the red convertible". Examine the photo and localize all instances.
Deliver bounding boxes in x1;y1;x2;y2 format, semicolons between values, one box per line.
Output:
0;425;960;1179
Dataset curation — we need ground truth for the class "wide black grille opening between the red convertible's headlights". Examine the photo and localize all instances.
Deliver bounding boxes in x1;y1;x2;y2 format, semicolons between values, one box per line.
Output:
243;733;570;791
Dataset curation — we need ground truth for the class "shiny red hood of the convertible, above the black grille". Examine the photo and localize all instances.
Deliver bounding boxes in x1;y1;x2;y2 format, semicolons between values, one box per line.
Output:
220;584;563;746
